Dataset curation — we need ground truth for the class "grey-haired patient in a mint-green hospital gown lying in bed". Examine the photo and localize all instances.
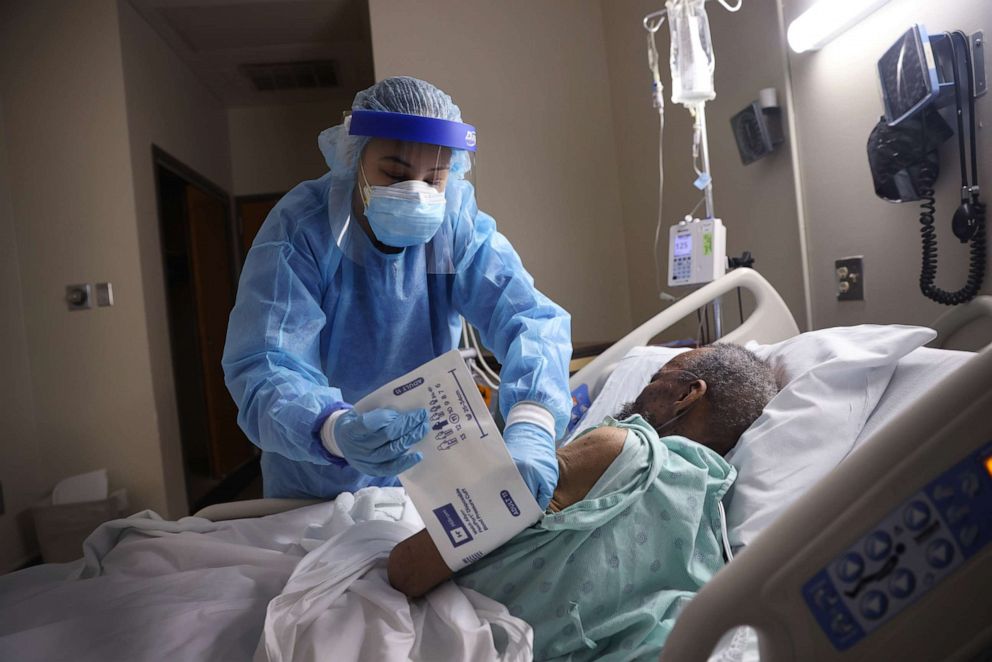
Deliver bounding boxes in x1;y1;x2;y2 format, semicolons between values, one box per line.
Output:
388;344;777;659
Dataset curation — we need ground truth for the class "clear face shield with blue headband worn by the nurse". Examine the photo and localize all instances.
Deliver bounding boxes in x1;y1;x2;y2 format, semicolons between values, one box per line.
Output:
336;110;475;273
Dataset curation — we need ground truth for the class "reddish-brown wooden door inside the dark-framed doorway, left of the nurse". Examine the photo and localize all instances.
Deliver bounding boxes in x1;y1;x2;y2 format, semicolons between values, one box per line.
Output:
186;185;254;478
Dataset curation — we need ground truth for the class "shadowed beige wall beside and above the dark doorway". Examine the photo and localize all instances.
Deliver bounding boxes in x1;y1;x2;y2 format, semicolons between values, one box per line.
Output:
118;0;232;517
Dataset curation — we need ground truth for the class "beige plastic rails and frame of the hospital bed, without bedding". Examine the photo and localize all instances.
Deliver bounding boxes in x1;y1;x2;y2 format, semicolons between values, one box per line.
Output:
571;269;992;662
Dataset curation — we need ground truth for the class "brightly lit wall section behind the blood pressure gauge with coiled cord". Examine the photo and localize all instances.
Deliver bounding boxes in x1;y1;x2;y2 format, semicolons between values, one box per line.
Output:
784;0;992;334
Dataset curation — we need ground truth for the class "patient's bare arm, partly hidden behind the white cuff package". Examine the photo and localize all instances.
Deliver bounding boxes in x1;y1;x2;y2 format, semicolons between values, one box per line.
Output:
387;427;627;598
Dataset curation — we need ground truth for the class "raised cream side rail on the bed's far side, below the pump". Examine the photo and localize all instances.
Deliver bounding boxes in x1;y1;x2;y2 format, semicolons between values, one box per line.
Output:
569;268;799;397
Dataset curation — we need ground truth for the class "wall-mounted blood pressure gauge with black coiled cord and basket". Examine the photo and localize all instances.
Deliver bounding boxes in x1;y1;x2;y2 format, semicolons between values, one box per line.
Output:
868;25;986;305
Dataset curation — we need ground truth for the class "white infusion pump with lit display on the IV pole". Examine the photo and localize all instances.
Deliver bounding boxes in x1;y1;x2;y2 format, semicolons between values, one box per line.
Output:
668;218;727;287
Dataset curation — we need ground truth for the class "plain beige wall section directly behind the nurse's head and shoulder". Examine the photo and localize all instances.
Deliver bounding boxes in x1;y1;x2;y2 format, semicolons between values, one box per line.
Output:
369;0;631;341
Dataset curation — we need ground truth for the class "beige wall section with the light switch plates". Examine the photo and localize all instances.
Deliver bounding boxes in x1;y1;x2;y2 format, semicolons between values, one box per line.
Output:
0;0;166;572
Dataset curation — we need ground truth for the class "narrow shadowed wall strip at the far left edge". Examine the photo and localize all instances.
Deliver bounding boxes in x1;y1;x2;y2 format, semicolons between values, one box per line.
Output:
0;94;48;574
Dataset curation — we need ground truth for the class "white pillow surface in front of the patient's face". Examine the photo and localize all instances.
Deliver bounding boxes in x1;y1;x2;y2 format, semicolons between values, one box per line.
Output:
564;347;689;444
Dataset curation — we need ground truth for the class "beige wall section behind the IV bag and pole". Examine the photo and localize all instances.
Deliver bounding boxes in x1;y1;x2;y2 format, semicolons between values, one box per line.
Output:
602;0;807;338
